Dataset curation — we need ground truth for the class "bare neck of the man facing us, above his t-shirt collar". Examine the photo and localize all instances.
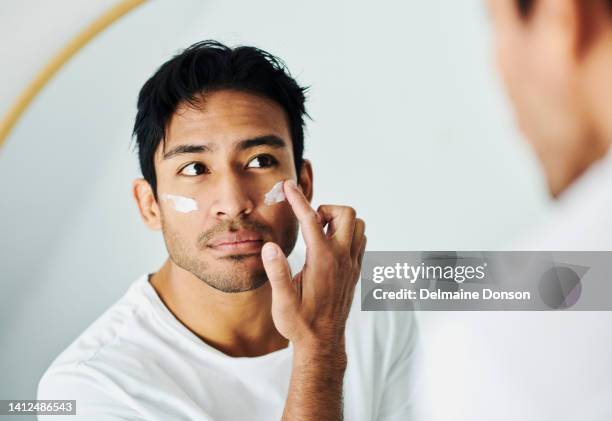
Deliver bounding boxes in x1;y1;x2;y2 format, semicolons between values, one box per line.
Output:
150;259;288;357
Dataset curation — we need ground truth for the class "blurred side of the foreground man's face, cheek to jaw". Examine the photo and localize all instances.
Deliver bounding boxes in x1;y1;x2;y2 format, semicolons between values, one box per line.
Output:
488;0;592;194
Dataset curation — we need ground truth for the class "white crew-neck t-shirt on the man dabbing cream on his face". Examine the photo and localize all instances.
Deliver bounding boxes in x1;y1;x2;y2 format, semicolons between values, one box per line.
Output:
38;275;417;421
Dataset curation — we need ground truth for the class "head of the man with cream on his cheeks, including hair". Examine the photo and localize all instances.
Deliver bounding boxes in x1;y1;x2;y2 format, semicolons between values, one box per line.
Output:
134;41;312;292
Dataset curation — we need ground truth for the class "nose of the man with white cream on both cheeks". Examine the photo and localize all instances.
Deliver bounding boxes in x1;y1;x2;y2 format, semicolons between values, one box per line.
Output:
210;174;254;219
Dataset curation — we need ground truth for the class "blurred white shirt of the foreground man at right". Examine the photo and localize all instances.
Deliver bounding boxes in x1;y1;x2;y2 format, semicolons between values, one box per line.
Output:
423;151;612;421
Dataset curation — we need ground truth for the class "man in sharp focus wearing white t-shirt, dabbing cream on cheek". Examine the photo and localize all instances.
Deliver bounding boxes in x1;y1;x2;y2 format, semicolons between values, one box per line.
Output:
38;41;416;421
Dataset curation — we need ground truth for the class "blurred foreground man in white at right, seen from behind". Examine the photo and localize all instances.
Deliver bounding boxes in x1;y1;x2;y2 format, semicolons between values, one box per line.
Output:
436;0;612;421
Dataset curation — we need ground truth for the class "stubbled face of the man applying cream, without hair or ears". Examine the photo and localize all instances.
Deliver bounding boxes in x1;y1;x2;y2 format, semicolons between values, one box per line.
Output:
155;90;302;292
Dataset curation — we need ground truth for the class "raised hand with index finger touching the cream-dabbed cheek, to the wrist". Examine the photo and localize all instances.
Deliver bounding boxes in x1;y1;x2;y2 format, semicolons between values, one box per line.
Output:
262;180;367;350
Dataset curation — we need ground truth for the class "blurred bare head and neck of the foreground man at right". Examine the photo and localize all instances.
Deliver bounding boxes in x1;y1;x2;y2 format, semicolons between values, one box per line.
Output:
488;0;612;195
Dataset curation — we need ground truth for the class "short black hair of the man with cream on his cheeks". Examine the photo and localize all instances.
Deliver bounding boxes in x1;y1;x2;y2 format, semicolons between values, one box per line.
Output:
133;40;308;199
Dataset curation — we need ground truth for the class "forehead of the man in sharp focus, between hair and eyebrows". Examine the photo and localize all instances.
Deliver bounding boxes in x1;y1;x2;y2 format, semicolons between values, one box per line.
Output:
159;90;291;153
